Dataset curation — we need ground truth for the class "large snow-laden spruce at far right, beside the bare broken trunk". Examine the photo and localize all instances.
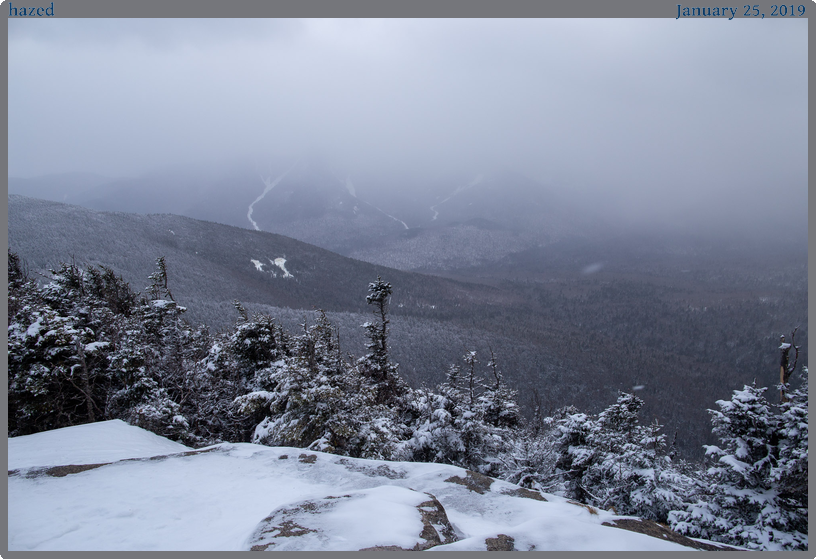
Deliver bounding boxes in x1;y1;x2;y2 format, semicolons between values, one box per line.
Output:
670;382;807;550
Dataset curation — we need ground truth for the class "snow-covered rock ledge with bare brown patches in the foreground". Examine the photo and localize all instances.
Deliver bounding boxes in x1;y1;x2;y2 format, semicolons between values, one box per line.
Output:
8;421;740;551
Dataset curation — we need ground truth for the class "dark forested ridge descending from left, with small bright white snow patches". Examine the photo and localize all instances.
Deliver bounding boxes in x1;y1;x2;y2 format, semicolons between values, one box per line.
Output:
9;195;498;324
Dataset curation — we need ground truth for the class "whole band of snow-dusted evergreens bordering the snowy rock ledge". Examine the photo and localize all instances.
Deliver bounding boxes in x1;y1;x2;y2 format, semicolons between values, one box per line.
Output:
8;252;808;549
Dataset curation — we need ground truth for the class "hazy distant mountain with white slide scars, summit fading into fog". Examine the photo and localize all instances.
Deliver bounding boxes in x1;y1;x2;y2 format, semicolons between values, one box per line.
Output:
9;157;597;270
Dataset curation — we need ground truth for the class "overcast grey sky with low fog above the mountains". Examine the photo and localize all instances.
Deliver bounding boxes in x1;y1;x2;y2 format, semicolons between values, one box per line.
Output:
8;19;808;232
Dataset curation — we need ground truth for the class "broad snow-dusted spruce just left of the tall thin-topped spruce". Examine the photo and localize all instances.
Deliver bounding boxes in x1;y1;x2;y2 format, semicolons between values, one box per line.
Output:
235;311;404;459
